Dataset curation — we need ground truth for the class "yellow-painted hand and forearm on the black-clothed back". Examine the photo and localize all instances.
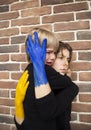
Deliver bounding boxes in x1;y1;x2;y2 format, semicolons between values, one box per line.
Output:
15;70;29;119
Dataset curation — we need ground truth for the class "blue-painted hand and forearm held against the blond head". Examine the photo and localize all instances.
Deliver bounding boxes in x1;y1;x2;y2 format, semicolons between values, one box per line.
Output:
26;32;48;87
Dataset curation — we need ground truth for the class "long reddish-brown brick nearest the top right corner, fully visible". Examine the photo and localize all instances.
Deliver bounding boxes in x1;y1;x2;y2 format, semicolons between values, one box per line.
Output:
54;2;88;13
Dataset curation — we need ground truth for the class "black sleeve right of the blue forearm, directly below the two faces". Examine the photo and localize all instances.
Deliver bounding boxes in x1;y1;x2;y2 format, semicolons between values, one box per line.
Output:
45;65;71;90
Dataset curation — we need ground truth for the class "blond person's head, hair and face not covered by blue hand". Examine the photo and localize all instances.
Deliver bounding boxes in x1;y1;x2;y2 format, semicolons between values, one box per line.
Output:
25;28;59;66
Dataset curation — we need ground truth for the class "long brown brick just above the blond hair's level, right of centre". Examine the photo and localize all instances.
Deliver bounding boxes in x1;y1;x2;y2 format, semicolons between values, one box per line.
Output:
42;13;74;23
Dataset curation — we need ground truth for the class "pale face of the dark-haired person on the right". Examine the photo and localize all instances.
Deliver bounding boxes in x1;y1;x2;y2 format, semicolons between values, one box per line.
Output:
53;49;70;75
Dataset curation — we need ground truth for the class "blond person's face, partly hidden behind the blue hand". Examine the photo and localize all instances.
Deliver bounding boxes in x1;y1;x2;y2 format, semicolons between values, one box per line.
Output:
45;47;56;66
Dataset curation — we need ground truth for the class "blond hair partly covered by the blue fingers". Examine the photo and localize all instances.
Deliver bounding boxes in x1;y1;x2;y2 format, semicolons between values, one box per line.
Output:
26;28;59;59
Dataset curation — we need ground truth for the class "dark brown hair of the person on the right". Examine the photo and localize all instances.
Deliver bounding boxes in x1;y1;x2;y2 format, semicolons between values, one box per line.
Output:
57;41;73;63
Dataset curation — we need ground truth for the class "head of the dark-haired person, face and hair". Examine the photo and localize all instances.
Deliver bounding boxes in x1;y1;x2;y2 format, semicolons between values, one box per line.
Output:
53;42;72;75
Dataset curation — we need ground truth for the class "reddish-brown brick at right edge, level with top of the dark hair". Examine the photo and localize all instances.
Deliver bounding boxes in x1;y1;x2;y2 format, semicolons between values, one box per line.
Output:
70;40;91;50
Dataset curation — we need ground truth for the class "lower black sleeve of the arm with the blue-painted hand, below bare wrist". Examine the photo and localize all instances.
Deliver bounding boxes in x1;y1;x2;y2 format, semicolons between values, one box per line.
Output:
36;83;79;120
